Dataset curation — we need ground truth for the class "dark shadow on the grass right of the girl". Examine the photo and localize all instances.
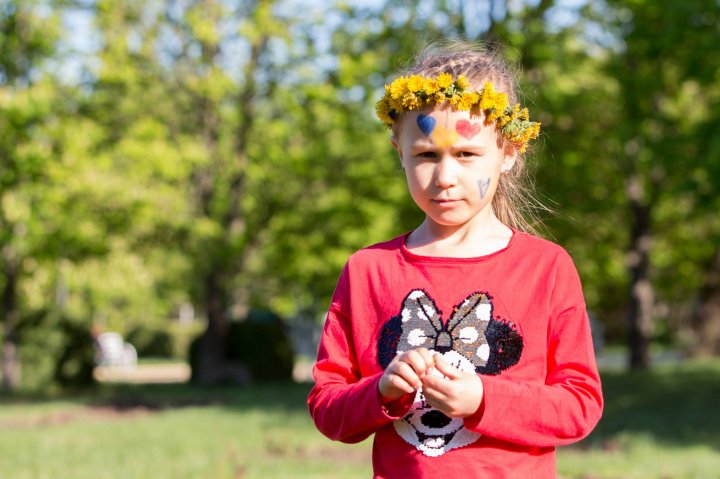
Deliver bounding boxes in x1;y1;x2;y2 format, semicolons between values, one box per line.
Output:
582;359;720;450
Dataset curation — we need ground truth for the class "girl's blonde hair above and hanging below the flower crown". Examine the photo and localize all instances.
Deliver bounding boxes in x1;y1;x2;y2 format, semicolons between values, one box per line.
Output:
400;40;550;234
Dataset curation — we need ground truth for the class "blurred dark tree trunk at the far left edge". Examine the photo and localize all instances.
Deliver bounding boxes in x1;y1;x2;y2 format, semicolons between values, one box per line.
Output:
0;263;21;391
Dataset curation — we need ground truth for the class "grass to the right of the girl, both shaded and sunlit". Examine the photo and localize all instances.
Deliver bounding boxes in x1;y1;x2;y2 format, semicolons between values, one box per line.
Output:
558;359;720;479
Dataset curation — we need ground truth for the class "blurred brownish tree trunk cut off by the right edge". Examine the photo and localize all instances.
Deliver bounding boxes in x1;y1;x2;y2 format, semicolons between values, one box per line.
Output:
691;249;720;356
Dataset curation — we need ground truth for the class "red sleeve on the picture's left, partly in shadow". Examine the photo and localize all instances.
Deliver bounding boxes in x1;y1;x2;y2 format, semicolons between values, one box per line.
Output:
308;267;412;443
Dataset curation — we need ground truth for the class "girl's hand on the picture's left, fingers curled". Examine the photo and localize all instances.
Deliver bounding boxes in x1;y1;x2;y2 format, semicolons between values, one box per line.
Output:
378;348;433;404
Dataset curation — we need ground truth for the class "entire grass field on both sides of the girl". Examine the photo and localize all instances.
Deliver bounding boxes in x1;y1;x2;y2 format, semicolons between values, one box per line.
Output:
0;360;720;479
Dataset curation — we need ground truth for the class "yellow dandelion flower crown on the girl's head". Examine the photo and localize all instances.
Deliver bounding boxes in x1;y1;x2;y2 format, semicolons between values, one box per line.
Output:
375;73;540;153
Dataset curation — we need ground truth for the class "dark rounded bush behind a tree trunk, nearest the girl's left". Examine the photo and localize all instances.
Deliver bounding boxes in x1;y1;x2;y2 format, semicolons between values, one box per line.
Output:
189;310;295;382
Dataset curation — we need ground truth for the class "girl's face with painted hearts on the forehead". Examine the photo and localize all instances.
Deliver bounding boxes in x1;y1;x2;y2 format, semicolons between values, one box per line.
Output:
392;107;515;232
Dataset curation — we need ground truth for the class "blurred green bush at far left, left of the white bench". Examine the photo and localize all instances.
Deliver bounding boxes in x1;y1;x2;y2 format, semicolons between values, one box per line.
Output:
17;310;95;391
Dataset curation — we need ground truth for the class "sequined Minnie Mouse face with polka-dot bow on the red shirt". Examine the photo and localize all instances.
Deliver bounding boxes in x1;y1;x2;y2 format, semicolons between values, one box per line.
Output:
378;289;523;457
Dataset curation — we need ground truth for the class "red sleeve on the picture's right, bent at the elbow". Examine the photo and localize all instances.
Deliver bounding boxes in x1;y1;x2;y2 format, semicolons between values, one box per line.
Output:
465;253;603;447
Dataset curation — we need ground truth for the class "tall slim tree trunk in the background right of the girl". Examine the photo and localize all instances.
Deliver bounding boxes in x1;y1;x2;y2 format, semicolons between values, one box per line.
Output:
626;172;655;369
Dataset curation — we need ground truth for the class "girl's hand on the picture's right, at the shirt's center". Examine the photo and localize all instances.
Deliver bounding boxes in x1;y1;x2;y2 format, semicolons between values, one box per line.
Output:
422;354;484;418
